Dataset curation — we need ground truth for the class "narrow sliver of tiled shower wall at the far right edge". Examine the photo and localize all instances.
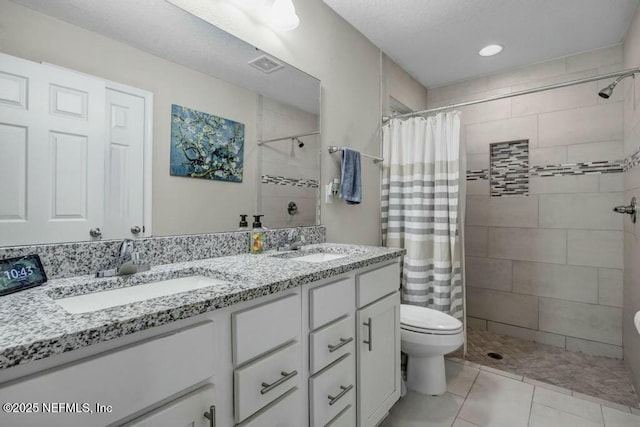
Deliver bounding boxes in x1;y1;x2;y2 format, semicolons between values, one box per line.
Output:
621;2;640;390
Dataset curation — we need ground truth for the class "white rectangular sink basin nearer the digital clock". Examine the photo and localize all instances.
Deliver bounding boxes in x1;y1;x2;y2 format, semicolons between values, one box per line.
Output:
55;276;227;314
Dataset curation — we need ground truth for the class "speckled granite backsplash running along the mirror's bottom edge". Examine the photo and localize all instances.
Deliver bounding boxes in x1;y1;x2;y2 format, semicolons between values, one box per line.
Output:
0;226;326;279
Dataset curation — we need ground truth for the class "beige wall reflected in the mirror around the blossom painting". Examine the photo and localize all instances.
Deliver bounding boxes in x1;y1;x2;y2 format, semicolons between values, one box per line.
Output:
0;0;257;235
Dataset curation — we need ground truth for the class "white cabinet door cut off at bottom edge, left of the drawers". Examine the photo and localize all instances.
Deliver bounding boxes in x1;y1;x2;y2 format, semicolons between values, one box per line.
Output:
123;385;215;427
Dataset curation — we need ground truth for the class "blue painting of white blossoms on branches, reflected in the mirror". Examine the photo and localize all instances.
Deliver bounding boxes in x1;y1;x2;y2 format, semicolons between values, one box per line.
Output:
171;105;244;182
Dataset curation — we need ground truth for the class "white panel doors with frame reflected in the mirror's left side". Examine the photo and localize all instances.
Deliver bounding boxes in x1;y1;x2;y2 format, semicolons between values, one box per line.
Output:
0;54;151;246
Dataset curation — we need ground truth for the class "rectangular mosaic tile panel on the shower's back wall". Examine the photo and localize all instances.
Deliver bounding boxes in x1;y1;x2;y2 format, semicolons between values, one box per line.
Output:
489;140;529;197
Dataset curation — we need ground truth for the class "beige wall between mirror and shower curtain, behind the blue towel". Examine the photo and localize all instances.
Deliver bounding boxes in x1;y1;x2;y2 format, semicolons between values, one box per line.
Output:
172;0;424;245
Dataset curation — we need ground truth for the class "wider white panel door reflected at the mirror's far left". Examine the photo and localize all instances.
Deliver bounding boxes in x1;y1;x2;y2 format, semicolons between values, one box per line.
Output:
0;54;105;246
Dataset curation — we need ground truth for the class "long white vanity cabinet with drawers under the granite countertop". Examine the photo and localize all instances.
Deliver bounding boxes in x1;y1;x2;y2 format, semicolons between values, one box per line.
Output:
0;262;400;427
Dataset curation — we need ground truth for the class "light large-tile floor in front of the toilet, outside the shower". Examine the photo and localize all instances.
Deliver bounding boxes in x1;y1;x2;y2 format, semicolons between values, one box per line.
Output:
380;359;640;427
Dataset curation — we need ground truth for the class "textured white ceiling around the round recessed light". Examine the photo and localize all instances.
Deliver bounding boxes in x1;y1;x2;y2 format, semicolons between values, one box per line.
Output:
324;0;638;87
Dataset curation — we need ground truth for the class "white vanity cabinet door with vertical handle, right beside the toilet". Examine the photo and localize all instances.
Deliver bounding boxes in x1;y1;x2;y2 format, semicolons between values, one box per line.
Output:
356;292;400;427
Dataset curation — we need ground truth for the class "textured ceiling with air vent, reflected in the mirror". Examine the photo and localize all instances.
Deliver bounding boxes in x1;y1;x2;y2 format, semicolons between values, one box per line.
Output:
6;0;320;114
